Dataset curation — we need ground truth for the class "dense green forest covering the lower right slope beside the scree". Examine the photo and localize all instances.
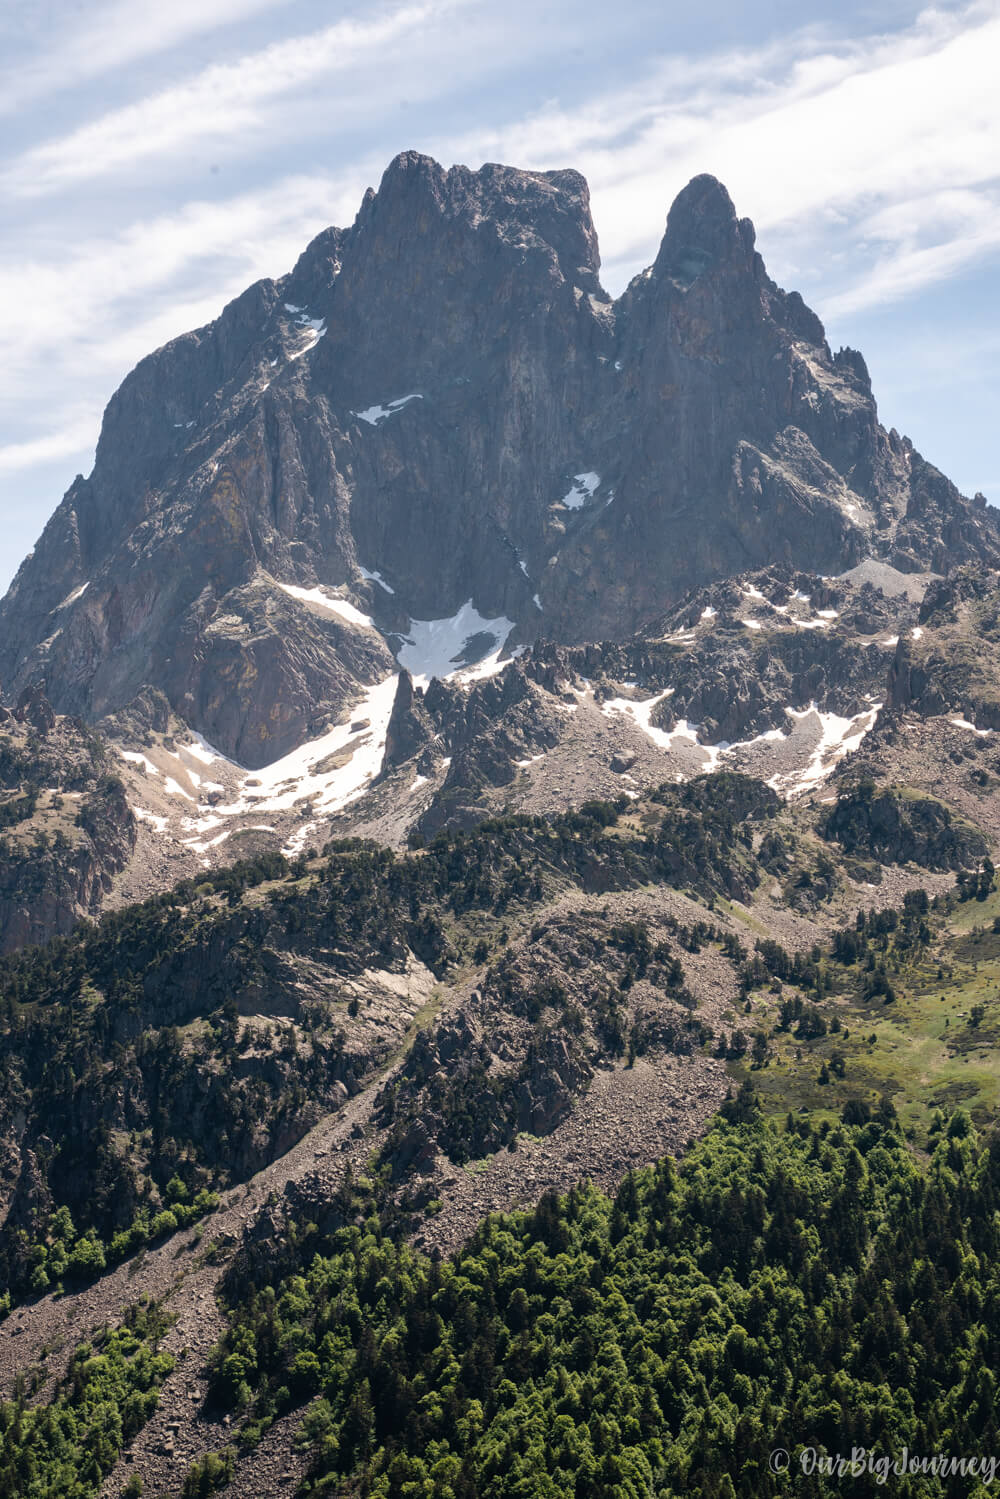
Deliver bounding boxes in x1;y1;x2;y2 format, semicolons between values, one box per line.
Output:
205;1088;1000;1499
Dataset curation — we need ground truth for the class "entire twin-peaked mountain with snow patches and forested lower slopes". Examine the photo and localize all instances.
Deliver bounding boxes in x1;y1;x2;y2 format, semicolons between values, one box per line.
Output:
0;153;1000;1499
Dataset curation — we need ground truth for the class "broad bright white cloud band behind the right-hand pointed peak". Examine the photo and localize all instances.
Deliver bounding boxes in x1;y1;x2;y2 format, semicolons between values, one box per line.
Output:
442;0;1000;310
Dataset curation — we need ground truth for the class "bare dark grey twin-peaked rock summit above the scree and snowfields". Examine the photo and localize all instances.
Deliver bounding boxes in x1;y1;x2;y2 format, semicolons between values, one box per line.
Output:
0;153;1000;766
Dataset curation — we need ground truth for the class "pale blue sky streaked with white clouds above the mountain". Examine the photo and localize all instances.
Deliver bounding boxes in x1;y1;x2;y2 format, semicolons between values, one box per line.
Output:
0;0;1000;589
